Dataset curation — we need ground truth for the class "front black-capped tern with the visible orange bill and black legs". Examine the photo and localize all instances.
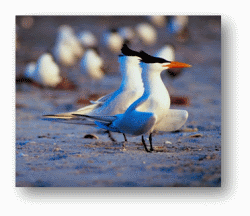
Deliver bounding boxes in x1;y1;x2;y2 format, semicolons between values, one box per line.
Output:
74;51;191;152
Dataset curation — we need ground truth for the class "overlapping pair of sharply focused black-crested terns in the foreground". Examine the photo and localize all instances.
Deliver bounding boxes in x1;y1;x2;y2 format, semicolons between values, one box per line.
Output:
45;46;190;152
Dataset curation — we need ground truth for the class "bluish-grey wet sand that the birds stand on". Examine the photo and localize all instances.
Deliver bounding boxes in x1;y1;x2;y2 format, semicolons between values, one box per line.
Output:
16;17;221;187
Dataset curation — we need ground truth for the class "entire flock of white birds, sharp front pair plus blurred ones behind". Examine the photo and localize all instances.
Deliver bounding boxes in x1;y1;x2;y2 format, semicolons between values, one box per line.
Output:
17;16;190;152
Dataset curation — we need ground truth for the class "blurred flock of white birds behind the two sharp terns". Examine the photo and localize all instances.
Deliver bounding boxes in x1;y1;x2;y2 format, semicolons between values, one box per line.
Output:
17;16;188;88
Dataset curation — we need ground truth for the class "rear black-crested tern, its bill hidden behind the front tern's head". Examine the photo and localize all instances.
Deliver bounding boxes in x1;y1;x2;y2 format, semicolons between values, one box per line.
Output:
44;44;144;141
